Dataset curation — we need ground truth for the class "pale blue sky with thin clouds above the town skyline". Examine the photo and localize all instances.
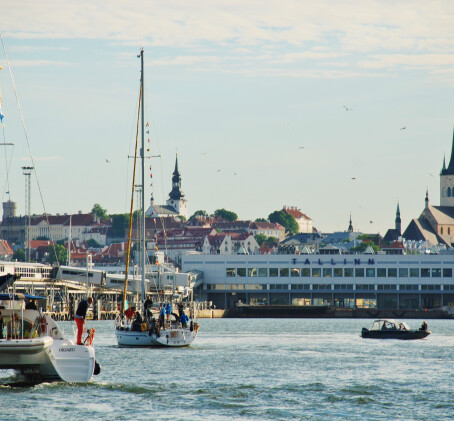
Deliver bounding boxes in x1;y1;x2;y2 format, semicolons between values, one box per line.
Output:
0;0;454;235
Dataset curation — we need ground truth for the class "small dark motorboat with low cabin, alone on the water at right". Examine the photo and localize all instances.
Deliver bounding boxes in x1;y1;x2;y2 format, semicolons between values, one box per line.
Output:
361;319;432;339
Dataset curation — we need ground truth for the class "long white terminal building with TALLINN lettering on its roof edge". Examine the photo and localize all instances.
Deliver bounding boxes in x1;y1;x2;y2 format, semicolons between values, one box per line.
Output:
182;254;454;310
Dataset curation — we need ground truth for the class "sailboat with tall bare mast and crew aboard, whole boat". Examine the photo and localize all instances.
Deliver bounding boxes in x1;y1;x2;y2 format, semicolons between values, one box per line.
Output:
115;49;199;347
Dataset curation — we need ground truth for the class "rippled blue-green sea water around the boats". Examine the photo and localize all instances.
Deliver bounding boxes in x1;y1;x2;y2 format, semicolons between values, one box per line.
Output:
0;319;454;420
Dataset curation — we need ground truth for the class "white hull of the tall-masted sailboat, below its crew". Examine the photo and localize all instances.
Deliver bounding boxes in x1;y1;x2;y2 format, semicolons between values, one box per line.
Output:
115;328;197;347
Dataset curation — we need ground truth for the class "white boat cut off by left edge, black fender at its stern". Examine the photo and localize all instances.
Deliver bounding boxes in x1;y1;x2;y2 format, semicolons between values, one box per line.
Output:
0;293;100;383
